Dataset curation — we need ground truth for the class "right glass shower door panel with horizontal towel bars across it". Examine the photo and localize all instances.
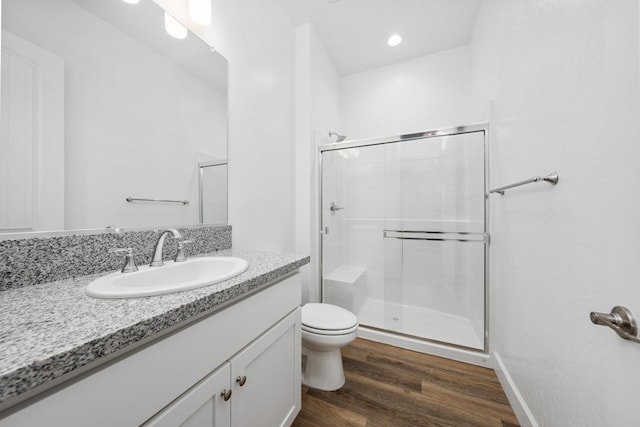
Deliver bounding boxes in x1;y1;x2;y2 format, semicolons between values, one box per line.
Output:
383;132;485;349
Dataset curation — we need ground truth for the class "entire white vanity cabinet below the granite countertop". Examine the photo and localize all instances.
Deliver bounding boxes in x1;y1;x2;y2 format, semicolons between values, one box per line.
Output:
0;274;301;427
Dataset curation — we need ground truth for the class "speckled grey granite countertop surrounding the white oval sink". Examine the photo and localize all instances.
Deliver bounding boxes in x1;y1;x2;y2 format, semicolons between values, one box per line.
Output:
0;249;309;407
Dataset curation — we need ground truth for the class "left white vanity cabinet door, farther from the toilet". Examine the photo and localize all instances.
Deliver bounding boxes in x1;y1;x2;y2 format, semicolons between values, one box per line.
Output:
144;362;231;427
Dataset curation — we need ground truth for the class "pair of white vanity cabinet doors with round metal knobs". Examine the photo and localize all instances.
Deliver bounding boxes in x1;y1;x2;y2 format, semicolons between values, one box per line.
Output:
144;309;300;427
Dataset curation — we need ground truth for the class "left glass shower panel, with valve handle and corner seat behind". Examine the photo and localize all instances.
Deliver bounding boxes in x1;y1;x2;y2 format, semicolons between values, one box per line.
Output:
322;146;385;318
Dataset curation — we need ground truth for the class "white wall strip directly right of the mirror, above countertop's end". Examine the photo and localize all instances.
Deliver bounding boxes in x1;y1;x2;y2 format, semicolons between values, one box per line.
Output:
200;0;295;252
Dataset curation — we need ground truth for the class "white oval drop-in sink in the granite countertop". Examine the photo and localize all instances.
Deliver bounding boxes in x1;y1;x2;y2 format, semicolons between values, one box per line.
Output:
85;257;249;298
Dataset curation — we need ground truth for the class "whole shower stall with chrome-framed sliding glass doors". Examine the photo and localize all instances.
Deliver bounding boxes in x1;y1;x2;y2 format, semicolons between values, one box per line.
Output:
320;125;488;353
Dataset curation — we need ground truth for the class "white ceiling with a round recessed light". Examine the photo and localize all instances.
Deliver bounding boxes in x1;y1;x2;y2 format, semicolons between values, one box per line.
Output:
281;0;481;75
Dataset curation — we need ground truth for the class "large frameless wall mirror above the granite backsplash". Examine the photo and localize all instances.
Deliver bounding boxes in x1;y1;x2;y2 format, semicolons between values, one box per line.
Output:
0;0;227;233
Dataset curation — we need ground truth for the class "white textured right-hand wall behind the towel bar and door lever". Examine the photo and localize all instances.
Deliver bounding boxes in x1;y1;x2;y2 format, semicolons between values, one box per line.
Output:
472;0;640;426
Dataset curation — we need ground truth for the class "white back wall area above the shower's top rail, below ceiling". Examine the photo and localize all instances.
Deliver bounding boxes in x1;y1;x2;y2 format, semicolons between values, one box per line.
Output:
340;46;471;139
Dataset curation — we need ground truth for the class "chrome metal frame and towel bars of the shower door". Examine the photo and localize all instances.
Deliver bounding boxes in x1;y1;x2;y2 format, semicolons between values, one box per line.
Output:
316;123;490;361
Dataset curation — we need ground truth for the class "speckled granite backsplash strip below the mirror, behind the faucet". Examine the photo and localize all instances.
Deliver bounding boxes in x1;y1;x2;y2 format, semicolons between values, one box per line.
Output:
0;225;231;291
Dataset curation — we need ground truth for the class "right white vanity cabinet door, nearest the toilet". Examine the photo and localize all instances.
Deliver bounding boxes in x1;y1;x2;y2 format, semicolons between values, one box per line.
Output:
231;308;301;427
